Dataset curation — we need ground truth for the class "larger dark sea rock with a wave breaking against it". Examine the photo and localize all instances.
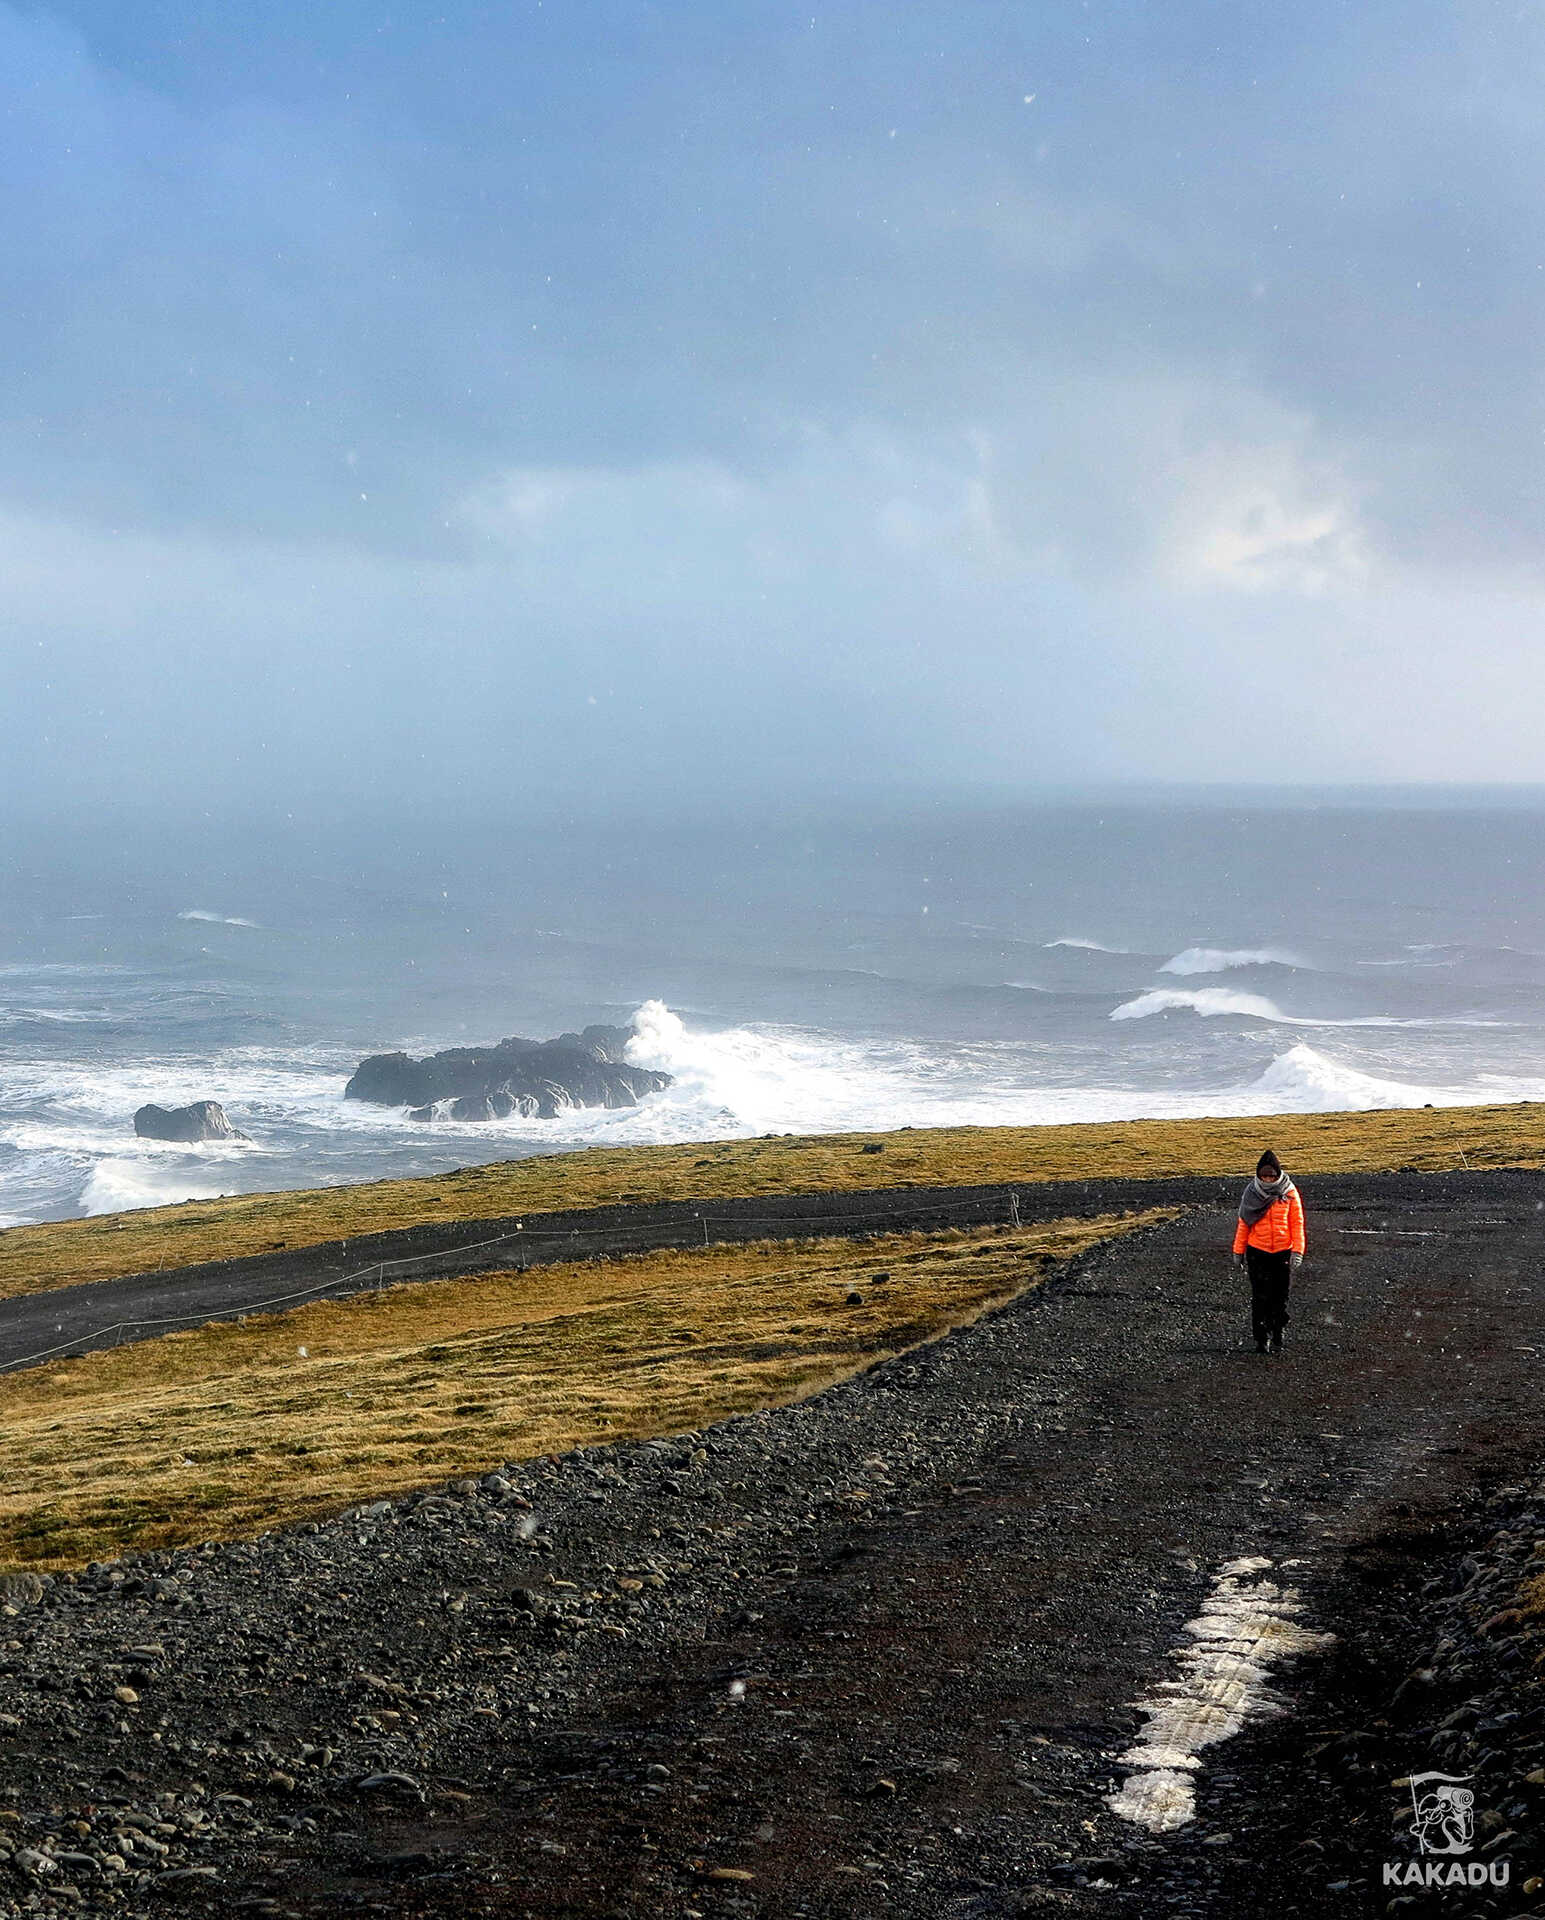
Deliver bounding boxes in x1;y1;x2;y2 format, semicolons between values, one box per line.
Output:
344;1027;670;1119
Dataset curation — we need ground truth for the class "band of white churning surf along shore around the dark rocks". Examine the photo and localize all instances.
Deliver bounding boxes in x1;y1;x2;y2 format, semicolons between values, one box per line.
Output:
0;989;1545;1219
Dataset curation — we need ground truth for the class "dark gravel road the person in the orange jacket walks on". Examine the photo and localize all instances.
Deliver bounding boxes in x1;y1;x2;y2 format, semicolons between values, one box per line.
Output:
0;1175;1545;1920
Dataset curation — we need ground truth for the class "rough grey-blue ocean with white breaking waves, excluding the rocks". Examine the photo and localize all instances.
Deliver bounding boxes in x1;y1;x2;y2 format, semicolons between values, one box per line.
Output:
0;793;1545;1225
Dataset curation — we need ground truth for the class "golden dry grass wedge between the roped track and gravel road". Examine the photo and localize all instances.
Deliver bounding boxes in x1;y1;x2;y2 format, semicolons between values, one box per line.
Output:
0;1210;1175;1569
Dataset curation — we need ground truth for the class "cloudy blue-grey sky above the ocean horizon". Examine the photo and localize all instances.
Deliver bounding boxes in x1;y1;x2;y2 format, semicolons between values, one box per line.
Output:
0;0;1545;801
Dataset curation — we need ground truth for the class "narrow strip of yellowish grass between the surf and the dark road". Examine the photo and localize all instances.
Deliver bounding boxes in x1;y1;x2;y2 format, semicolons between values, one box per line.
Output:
0;1102;1545;1300
